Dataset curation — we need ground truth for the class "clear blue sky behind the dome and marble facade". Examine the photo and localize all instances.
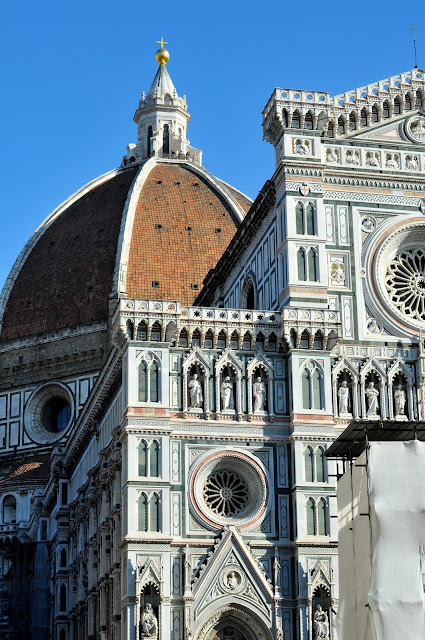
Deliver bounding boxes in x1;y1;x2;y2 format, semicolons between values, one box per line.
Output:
0;0;425;287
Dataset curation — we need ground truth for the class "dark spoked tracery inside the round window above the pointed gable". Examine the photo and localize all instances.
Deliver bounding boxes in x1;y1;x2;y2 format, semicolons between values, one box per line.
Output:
203;469;249;516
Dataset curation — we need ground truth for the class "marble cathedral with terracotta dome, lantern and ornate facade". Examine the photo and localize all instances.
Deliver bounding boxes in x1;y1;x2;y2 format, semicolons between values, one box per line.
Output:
0;41;425;640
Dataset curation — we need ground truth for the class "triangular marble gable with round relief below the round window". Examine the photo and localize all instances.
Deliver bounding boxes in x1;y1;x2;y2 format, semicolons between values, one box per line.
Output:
192;528;273;617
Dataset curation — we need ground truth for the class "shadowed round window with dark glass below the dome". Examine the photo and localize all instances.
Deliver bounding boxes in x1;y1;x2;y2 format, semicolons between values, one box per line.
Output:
24;382;74;444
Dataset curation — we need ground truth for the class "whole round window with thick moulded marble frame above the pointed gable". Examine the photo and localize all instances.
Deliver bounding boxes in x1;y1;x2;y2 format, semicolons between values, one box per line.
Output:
190;451;268;528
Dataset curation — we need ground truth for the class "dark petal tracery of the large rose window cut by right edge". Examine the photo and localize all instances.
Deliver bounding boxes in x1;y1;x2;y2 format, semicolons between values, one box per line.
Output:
385;249;425;320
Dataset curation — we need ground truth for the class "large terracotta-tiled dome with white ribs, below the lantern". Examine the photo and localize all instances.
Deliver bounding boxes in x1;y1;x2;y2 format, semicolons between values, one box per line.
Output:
0;158;250;341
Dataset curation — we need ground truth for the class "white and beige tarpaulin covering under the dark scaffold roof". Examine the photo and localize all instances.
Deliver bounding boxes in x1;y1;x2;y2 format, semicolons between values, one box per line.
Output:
337;440;425;640
